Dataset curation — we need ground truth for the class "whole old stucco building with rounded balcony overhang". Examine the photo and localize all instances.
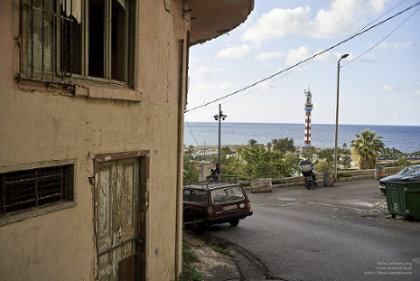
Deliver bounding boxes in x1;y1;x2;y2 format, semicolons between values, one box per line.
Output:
0;0;253;281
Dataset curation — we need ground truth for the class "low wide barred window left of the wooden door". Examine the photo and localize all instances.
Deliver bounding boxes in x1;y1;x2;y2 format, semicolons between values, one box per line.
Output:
0;165;74;216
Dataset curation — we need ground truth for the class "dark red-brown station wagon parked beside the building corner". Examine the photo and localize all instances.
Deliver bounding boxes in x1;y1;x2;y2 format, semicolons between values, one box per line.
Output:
184;182;252;226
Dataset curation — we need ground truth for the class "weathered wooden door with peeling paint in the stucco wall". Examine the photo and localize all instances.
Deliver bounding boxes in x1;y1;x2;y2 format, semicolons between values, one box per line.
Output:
95;158;140;281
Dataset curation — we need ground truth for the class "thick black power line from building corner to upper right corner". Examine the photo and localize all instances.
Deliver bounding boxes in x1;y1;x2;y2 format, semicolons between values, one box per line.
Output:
184;1;420;113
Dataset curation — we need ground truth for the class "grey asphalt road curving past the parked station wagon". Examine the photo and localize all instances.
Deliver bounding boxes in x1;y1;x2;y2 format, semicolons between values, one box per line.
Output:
206;180;420;281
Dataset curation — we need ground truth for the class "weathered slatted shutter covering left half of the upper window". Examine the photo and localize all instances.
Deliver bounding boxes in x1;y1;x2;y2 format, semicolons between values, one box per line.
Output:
19;0;81;83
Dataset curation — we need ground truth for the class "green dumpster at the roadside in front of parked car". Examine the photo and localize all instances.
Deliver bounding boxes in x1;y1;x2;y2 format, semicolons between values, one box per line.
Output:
385;180;420;220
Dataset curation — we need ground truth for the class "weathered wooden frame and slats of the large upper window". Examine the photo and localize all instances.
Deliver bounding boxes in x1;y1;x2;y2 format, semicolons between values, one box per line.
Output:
17;0;138;88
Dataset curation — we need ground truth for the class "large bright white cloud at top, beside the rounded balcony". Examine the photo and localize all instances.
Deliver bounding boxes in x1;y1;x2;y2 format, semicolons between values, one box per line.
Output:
242;0;389;43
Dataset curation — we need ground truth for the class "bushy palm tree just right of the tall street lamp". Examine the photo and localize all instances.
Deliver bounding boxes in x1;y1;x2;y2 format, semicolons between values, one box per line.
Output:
350;129;384;169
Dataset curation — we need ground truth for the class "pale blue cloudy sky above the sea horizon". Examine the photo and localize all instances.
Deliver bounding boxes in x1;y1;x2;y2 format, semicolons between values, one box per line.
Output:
185;0;420;126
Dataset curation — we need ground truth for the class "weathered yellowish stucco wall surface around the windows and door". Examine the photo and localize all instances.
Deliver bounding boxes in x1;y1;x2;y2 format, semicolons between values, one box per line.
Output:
0;0;186;281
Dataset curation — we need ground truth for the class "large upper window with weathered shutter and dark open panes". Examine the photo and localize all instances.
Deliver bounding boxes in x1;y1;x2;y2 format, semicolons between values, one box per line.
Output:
20;0;136;85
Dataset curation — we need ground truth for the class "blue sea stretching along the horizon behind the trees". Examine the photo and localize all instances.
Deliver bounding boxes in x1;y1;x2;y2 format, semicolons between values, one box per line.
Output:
184;122;420;153
